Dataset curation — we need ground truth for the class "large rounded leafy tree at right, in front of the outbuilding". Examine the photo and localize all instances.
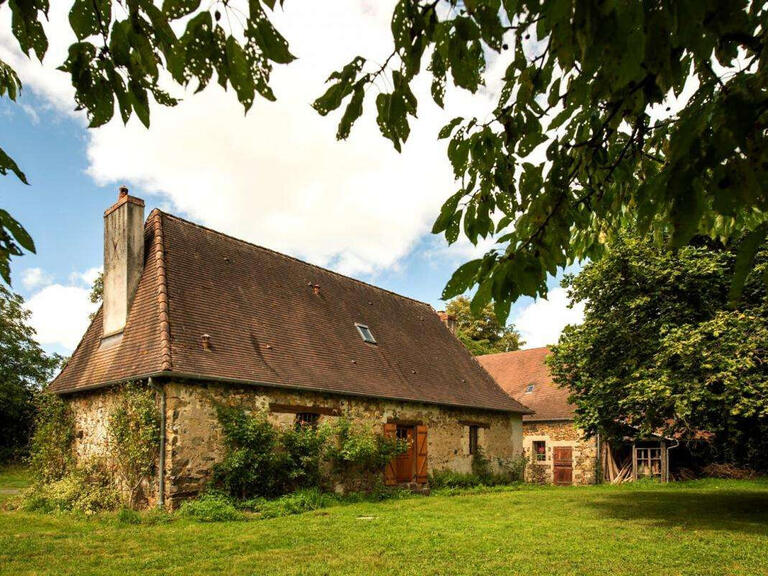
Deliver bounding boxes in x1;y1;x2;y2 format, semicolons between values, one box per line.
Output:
550;235;768;470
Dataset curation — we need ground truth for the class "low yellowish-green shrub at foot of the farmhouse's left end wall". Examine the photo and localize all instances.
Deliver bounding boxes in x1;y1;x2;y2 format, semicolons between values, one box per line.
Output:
21;460;121;514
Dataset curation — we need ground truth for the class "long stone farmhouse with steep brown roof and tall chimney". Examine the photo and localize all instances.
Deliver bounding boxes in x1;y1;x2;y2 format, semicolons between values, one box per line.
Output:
50;188;531;506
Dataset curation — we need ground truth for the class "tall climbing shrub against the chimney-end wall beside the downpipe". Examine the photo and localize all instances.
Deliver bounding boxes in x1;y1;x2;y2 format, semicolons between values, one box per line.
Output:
108;383;160;506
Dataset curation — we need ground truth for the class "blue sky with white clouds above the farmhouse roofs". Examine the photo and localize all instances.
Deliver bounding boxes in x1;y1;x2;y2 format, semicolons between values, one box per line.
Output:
0;0;581;353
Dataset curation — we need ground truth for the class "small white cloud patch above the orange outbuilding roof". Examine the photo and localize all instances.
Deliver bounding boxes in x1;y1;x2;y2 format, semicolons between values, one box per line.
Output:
513;288;584;348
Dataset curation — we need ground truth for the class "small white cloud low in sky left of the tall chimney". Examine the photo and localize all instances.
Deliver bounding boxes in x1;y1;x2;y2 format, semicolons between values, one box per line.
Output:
26;284;98;351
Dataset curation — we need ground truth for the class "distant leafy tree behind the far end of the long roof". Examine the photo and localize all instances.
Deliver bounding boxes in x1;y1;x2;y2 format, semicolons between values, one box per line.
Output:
445;296;524;356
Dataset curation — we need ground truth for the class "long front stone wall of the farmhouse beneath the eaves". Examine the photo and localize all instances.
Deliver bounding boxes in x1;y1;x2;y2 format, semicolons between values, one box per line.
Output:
165;382;523;504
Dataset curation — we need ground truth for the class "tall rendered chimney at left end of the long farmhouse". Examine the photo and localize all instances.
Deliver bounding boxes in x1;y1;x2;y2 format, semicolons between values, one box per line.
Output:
103;186;144;336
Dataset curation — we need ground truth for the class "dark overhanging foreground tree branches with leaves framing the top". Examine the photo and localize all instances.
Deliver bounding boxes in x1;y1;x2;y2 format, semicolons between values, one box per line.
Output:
0;0;768;320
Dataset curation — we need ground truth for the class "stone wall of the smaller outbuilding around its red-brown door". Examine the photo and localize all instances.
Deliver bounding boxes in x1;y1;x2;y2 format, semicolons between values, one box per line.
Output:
523;420;597;484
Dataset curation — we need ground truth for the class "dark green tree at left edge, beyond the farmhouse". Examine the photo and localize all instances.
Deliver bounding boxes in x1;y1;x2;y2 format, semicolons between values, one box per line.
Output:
0;285;59;463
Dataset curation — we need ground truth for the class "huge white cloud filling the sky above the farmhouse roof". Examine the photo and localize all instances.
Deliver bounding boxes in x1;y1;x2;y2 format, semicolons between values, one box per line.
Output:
81;0;498;274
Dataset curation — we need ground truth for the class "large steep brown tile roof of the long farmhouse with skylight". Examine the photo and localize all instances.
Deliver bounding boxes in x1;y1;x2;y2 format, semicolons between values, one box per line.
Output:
51;210;528;413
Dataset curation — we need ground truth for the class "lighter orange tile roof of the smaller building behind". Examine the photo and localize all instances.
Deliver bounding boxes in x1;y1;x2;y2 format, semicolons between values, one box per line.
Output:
478;348;574;421
